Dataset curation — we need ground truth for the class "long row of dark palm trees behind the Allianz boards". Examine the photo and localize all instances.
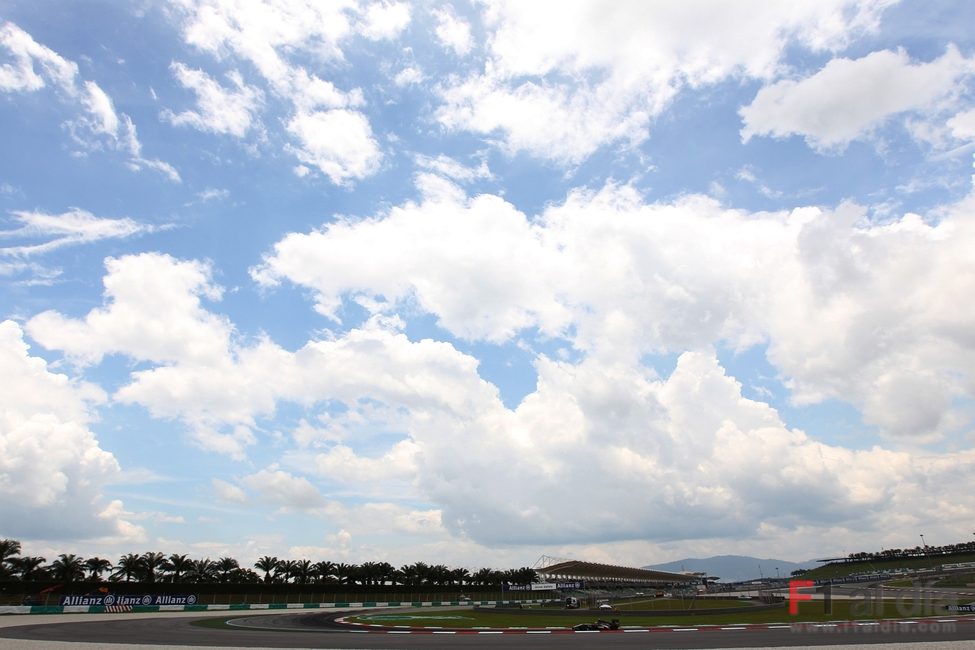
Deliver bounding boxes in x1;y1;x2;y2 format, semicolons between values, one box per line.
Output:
0;539;536;587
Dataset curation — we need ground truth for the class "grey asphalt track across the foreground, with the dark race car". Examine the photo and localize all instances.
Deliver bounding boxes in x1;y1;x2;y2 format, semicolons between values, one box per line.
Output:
0;612;975;650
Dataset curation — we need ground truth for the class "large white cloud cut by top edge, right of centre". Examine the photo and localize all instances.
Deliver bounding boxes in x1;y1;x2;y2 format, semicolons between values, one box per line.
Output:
437;0;888;163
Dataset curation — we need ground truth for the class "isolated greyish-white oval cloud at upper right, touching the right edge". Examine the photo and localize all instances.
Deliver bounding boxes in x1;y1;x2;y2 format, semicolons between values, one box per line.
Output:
740;47;975;151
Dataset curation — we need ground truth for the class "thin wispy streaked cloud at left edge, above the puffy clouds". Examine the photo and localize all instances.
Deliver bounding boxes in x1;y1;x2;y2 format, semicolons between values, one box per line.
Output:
0;208;157;256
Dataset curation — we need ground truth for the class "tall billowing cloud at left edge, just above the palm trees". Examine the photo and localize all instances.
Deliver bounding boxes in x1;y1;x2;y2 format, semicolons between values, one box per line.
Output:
0;321;143;541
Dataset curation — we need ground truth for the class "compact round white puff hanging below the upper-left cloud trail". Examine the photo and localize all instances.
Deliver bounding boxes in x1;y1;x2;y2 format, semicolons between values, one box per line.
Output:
288;109;382;185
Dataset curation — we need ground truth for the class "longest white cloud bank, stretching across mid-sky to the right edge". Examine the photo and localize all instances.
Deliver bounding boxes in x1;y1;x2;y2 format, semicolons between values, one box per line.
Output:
252;177;975;436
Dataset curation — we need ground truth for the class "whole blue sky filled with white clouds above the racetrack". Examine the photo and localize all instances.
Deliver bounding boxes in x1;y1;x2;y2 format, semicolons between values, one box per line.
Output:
0;0;975;568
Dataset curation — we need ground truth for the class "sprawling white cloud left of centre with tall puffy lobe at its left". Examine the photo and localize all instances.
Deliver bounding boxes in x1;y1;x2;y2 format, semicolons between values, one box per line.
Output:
27;253;497;459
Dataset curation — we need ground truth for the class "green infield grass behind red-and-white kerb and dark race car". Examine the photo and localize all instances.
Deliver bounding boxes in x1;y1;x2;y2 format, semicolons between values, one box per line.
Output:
349;599;968;628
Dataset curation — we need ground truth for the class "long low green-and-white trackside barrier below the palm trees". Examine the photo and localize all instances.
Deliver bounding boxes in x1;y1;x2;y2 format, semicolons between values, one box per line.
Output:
0;599;548;615
